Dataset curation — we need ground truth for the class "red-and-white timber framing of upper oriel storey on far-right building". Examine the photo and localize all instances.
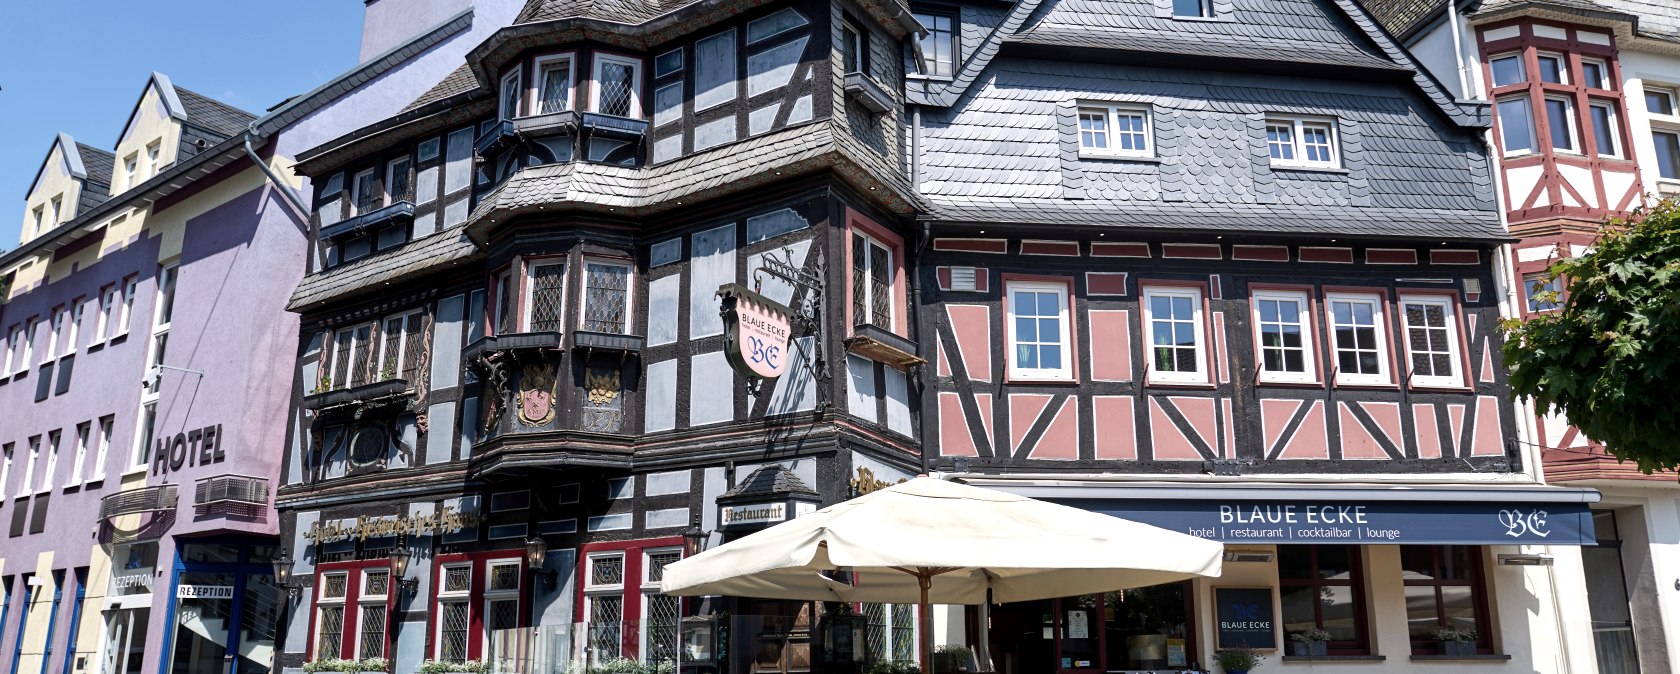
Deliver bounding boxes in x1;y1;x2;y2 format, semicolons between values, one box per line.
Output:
1477;18;1641;226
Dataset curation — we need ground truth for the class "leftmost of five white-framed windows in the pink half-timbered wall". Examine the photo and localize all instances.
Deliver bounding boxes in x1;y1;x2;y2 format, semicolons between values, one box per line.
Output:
1005;281;1074;380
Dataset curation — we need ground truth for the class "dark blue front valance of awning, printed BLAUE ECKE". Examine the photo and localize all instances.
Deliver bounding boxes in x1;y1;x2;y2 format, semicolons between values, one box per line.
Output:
1058;499;1596;545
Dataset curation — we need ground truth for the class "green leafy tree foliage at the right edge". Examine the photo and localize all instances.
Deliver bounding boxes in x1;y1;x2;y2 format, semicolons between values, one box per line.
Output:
1504;200;1680;474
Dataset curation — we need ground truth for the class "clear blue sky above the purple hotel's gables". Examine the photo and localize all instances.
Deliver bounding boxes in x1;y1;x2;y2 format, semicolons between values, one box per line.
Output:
0;0;363;250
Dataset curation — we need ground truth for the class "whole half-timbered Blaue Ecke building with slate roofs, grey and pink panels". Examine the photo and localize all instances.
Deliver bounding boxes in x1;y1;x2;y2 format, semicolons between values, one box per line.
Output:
265;0;1598;674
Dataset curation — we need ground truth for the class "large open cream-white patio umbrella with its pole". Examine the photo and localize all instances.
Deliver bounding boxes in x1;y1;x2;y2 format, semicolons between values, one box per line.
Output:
660;477;1225;672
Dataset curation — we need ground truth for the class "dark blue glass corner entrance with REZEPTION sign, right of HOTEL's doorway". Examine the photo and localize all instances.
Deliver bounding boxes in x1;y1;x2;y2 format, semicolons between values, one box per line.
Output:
168;541;282;674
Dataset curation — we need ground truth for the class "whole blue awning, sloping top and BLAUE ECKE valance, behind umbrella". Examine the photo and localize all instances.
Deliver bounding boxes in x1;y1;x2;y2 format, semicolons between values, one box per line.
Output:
964;477;1599;545
